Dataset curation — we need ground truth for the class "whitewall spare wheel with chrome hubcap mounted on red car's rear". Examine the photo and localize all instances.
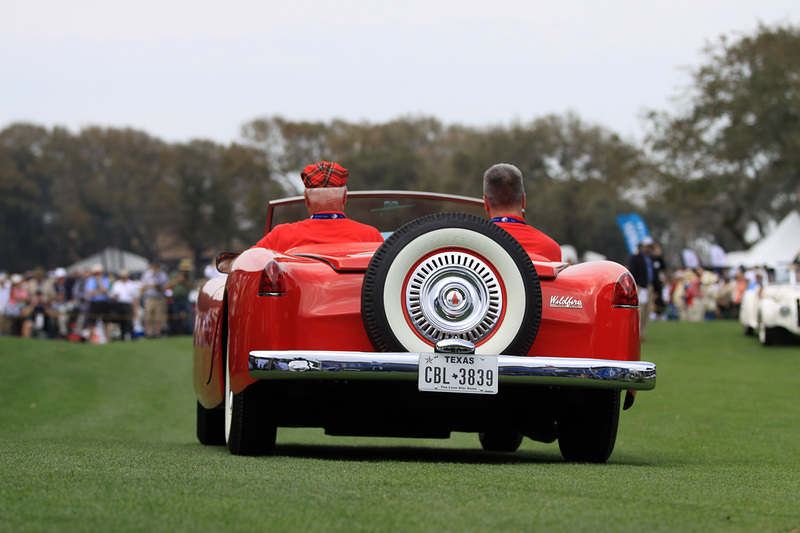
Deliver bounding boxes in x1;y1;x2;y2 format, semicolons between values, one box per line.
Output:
361;213;542;355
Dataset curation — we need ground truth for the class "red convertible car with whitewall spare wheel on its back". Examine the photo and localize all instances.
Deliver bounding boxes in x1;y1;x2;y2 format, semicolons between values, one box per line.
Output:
194;191;656;463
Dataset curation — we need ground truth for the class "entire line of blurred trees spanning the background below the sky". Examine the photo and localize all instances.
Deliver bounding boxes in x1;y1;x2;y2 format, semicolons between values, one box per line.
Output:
0;22;800;270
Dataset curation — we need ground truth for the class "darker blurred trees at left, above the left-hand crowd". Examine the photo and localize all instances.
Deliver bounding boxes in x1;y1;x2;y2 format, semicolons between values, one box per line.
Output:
0;124;283;271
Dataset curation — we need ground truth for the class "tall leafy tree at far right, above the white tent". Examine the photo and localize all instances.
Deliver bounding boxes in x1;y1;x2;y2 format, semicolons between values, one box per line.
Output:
650;25;800;249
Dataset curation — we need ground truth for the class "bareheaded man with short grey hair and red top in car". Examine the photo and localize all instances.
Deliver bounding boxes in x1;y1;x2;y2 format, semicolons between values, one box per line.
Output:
483;163;561;261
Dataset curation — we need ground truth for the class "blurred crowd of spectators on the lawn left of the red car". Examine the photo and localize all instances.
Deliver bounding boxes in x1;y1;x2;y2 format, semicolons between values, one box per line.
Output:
0;260;206;343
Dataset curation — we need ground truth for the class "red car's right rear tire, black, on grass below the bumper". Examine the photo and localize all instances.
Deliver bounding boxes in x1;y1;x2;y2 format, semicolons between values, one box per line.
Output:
556;390;620;463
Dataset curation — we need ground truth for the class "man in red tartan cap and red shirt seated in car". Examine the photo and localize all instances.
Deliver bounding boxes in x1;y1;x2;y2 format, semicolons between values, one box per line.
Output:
254;161;383;253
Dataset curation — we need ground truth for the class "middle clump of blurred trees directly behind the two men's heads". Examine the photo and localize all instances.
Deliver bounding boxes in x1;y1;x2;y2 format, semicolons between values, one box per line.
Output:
239;114;655;261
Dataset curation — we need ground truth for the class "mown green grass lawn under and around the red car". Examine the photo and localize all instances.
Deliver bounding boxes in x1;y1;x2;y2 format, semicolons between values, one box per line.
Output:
0;322;800;533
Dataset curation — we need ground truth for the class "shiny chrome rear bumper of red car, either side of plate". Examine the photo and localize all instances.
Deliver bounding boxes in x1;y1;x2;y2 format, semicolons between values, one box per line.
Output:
249;350;656;390
